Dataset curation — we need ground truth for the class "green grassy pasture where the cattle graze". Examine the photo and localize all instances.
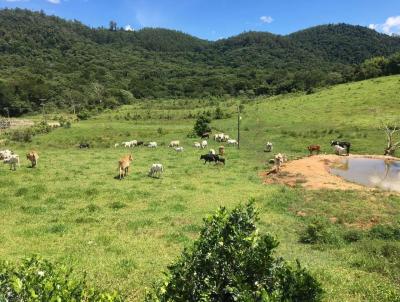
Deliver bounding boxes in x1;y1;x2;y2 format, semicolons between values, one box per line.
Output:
0;76;400;301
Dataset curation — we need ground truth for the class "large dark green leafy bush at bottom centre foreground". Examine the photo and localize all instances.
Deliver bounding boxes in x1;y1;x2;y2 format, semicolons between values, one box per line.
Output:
146;203;322;302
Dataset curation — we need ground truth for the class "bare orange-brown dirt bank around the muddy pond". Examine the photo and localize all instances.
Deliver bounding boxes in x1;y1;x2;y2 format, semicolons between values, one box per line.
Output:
262;154;387;190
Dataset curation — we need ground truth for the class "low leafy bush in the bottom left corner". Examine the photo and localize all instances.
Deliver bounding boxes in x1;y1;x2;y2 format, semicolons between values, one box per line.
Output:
0;257;123;302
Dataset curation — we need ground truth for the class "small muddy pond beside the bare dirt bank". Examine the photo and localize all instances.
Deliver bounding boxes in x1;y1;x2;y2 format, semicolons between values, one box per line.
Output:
330;157;400;192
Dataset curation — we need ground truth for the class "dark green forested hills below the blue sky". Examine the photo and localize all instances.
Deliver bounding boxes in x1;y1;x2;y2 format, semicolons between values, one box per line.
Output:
0;9;400;115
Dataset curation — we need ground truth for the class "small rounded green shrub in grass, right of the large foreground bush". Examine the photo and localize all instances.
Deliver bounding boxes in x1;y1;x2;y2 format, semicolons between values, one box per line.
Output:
300;218;341;244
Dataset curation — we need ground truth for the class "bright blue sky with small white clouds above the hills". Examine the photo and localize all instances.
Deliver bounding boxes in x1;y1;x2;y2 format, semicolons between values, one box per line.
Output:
0;0;400;40
